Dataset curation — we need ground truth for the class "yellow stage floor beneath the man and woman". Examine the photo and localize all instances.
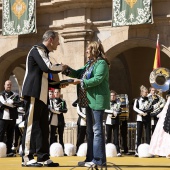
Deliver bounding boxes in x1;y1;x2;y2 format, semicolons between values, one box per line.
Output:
0;155;170;170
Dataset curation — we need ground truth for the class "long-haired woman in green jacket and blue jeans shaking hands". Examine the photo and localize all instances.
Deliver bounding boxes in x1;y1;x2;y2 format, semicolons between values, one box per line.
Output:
64;41;110;167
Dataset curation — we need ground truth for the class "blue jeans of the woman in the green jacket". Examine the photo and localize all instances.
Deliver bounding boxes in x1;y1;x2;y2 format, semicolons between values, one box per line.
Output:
85;108;106;165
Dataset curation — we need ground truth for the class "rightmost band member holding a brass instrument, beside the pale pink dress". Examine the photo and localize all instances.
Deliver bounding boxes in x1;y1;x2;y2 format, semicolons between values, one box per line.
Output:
148;87;165;134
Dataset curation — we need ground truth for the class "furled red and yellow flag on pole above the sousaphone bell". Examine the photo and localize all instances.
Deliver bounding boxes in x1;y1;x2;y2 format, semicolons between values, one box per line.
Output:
153;34;161;70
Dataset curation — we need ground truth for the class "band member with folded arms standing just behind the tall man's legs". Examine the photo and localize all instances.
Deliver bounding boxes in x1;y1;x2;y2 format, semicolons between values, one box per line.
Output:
54;89;67;156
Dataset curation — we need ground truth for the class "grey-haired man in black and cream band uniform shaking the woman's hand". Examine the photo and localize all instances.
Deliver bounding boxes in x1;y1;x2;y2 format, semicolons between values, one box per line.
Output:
22;30;66;167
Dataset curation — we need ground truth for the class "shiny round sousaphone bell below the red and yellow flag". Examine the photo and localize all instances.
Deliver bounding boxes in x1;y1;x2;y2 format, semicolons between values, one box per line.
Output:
149;67;170;92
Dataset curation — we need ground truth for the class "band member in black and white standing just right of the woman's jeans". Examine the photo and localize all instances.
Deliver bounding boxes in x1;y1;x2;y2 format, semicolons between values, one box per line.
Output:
105;90;122;157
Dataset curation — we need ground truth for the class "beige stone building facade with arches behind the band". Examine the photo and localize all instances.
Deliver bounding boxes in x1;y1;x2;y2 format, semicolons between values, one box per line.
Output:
0;0;170;121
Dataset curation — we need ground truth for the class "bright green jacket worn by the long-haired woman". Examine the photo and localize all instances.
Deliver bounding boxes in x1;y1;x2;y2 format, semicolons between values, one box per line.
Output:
69;60;110;110
